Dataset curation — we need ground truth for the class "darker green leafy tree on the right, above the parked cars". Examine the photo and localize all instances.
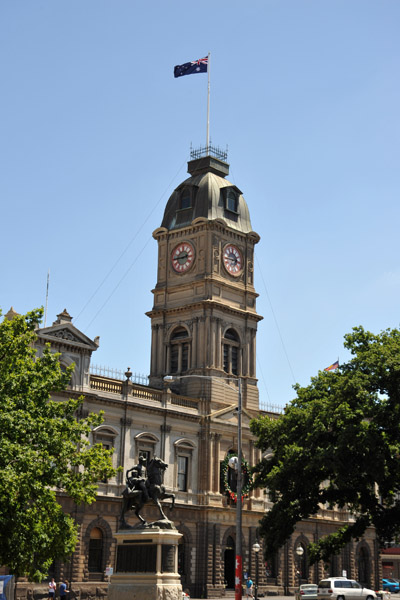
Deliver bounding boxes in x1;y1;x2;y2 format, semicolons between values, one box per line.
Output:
251;327;400;563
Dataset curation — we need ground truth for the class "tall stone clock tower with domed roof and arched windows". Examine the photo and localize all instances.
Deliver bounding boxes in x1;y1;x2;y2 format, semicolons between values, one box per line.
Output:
147;153;262;409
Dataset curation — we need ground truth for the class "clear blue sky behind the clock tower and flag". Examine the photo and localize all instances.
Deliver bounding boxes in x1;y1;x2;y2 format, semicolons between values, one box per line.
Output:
0;0;400;405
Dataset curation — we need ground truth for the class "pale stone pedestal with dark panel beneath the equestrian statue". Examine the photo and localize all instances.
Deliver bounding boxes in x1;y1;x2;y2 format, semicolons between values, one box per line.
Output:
108;527;182;600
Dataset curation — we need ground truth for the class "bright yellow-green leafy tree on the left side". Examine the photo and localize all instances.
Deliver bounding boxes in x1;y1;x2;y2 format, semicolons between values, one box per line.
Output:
0;309;115;581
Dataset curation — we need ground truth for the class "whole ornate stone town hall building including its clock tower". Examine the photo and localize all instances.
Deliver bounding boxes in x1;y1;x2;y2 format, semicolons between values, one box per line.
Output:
8;153;381;599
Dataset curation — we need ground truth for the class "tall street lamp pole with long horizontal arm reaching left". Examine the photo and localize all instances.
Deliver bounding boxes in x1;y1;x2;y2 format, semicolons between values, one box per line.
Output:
164;374;243;600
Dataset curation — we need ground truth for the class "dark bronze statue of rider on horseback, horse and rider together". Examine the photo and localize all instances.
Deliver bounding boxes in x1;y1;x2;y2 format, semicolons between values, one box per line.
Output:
119;455;175;529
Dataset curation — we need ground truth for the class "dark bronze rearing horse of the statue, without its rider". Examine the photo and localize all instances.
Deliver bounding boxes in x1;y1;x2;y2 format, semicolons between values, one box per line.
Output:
119;456;175;529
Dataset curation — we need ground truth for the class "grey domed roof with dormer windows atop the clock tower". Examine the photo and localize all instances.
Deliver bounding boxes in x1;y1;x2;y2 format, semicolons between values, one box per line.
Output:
161;156;252;233
